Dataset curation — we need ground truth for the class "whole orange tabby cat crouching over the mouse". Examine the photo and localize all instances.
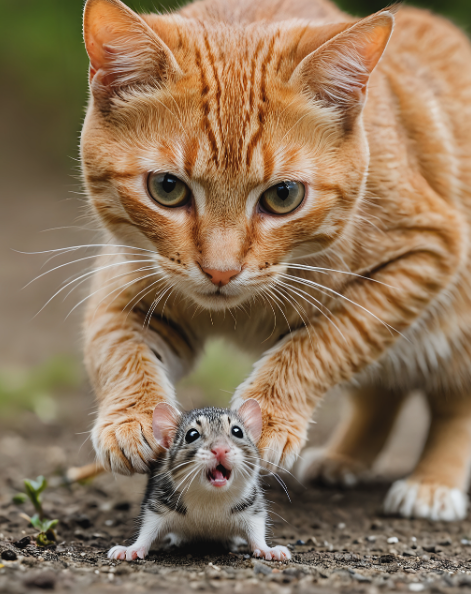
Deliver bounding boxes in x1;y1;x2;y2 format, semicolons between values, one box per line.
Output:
82;0;471;520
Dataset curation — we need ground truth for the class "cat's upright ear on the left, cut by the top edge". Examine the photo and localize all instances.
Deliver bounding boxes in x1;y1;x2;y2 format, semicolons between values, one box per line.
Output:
83;0;180;94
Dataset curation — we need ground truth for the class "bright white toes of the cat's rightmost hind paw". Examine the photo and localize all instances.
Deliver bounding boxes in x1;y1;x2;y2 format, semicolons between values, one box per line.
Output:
384;479;468;522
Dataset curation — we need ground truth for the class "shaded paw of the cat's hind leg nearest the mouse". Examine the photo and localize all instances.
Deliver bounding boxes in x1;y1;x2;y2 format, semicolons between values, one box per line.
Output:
296;448;369;487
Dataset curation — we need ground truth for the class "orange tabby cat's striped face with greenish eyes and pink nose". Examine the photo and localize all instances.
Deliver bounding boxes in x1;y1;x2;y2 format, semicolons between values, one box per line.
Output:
82;0;394;309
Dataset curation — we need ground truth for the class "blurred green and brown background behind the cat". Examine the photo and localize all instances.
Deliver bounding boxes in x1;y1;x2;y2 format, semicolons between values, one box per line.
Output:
0;0;471;422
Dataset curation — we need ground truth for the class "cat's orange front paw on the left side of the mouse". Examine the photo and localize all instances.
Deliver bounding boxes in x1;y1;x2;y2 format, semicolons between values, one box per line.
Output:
92;413;159;475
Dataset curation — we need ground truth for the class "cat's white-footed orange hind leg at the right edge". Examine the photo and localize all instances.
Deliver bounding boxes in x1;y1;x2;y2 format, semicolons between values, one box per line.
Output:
384;395;471;521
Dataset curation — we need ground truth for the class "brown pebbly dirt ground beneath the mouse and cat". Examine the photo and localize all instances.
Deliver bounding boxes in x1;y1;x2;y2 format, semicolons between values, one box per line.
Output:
0;391;471;594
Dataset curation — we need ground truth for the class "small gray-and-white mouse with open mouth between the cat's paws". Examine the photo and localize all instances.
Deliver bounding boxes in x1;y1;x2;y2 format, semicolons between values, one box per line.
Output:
108;399;291;561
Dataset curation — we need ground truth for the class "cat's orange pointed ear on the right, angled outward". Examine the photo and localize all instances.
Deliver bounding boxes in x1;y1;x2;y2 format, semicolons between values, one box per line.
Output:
291;11;394;115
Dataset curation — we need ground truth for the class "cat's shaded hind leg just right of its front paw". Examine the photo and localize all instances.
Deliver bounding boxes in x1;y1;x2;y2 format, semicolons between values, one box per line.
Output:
296;386;404;487
